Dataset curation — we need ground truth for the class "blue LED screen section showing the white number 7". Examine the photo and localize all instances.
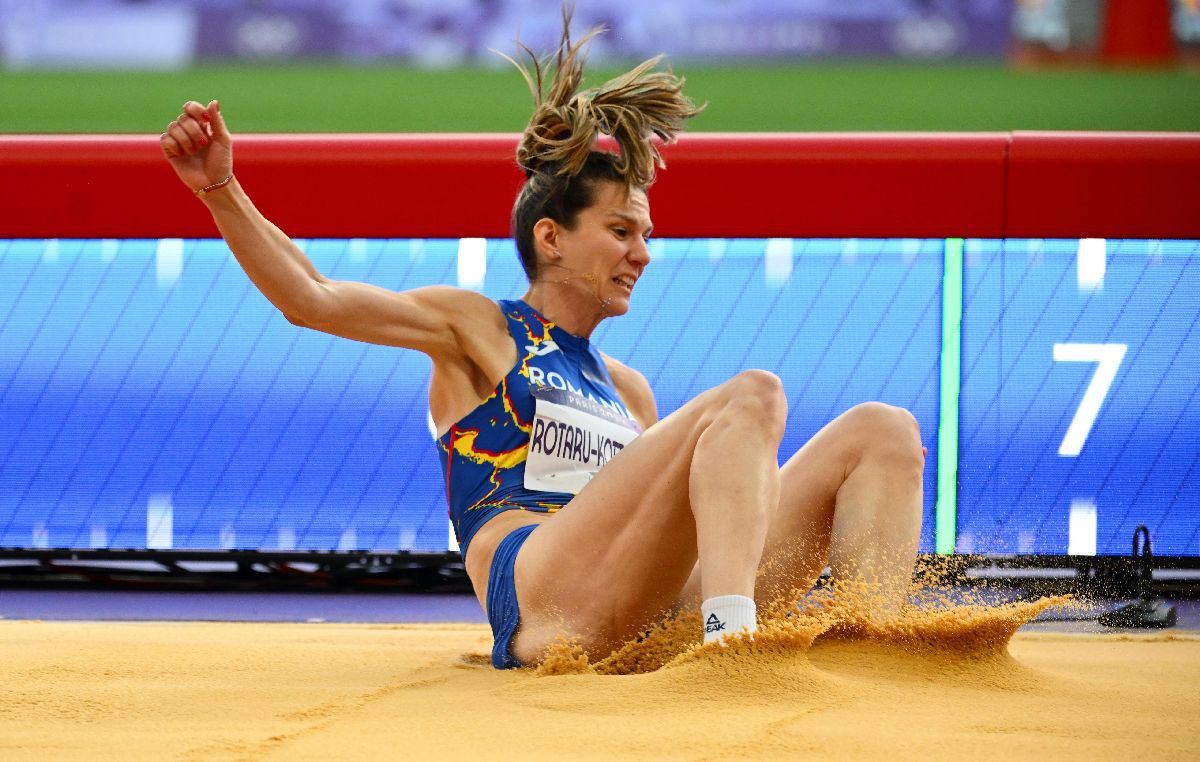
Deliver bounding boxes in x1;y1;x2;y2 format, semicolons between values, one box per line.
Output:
956;239;1200;556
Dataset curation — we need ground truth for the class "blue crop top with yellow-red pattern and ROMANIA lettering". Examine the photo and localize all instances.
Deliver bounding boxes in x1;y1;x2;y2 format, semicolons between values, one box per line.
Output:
438;300;636;558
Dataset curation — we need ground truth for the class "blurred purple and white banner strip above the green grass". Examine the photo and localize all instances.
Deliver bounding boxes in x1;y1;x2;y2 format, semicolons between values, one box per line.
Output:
0;0;1014;68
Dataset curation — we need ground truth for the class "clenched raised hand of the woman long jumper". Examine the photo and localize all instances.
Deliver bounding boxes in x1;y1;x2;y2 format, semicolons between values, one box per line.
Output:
158;101;233;191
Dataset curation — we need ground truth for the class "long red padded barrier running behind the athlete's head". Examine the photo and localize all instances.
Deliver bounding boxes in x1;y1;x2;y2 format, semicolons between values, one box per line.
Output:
0;132;1200;238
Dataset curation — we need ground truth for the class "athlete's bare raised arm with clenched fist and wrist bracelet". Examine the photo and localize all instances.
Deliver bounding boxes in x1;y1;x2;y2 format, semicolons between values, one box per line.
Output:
160;101;494;355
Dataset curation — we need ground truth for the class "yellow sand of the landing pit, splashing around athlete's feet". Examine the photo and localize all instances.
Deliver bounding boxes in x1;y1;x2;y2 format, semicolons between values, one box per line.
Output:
0;604;1200;762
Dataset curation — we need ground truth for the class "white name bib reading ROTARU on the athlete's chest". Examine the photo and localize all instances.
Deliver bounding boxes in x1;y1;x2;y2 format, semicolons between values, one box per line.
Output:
524;386;642;494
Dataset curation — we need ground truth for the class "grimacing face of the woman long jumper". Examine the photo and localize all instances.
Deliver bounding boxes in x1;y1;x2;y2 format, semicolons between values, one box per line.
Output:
551;181;654;314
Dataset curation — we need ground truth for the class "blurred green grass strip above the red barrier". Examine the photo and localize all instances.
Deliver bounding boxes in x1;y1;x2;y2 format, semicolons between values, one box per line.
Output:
0;64;1200;133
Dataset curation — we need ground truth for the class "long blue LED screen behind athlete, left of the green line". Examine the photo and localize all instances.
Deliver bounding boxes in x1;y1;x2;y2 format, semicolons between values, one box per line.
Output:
0;239;943;551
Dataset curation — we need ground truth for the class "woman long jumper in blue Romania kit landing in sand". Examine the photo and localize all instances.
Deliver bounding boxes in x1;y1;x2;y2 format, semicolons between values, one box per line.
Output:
161;23;924;667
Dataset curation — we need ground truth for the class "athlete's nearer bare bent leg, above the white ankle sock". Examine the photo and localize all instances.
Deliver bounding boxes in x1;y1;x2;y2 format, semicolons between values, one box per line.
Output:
494;371;787;662
